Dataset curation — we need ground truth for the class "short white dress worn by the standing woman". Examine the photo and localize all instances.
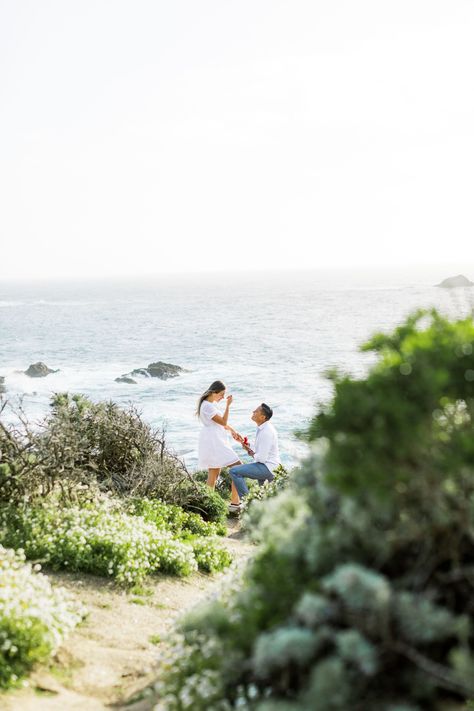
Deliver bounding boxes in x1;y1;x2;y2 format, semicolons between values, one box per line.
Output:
199;400;239;469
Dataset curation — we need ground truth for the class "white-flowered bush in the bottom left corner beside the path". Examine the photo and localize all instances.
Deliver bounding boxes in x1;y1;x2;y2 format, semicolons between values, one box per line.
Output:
0;546;85;689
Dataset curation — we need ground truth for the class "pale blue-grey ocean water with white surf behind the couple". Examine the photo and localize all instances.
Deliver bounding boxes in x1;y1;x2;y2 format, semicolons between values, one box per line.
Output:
0;270;474;469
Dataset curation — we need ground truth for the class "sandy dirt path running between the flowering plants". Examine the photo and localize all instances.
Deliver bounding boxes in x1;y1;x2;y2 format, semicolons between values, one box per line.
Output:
0;519;252;711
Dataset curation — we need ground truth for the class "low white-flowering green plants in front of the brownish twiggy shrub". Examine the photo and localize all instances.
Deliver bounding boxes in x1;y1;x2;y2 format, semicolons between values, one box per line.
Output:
0;497;230;585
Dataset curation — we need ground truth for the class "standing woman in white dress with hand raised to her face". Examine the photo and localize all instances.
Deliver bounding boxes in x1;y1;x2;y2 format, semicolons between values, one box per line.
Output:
196;380;242;506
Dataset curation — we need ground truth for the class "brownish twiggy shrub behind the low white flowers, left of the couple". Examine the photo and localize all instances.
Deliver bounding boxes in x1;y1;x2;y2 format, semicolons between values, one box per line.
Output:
0;393;218;521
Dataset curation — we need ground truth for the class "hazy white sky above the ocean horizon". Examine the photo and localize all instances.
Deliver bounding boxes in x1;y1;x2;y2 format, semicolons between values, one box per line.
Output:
0;0;474;278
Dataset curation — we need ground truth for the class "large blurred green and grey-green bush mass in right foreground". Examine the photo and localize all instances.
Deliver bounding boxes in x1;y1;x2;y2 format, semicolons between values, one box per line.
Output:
156;311;474;711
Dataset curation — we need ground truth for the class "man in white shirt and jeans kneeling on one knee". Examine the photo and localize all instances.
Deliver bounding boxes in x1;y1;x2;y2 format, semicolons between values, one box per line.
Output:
229;402;280;512
